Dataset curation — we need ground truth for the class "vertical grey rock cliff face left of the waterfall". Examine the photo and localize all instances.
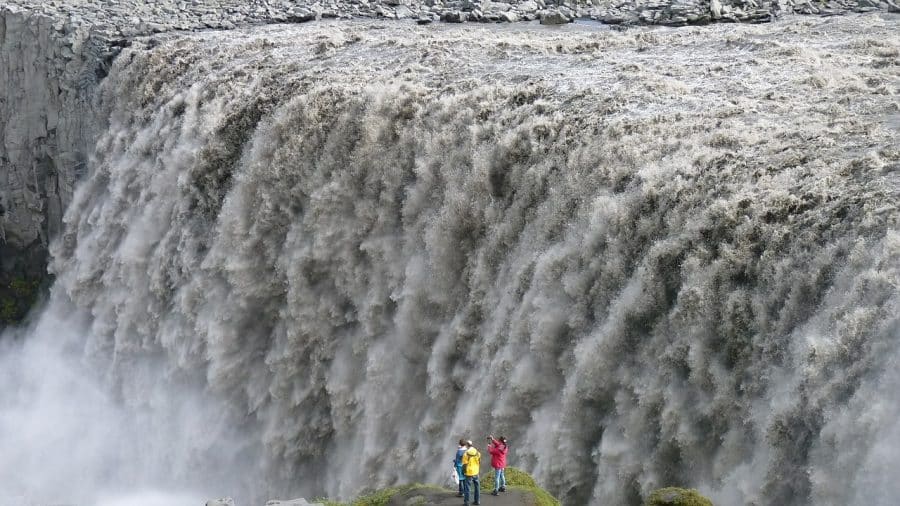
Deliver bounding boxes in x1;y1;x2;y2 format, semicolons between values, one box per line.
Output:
0;8;95;252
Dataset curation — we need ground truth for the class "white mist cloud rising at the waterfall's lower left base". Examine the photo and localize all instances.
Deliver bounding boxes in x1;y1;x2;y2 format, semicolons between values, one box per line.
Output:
0;288;259;506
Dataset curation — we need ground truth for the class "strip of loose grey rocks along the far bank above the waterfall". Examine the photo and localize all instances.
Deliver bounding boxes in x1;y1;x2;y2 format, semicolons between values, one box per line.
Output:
0;0;898;38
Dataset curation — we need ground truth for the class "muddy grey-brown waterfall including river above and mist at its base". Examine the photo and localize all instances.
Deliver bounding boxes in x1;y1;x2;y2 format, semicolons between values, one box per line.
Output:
0;16;900;505
